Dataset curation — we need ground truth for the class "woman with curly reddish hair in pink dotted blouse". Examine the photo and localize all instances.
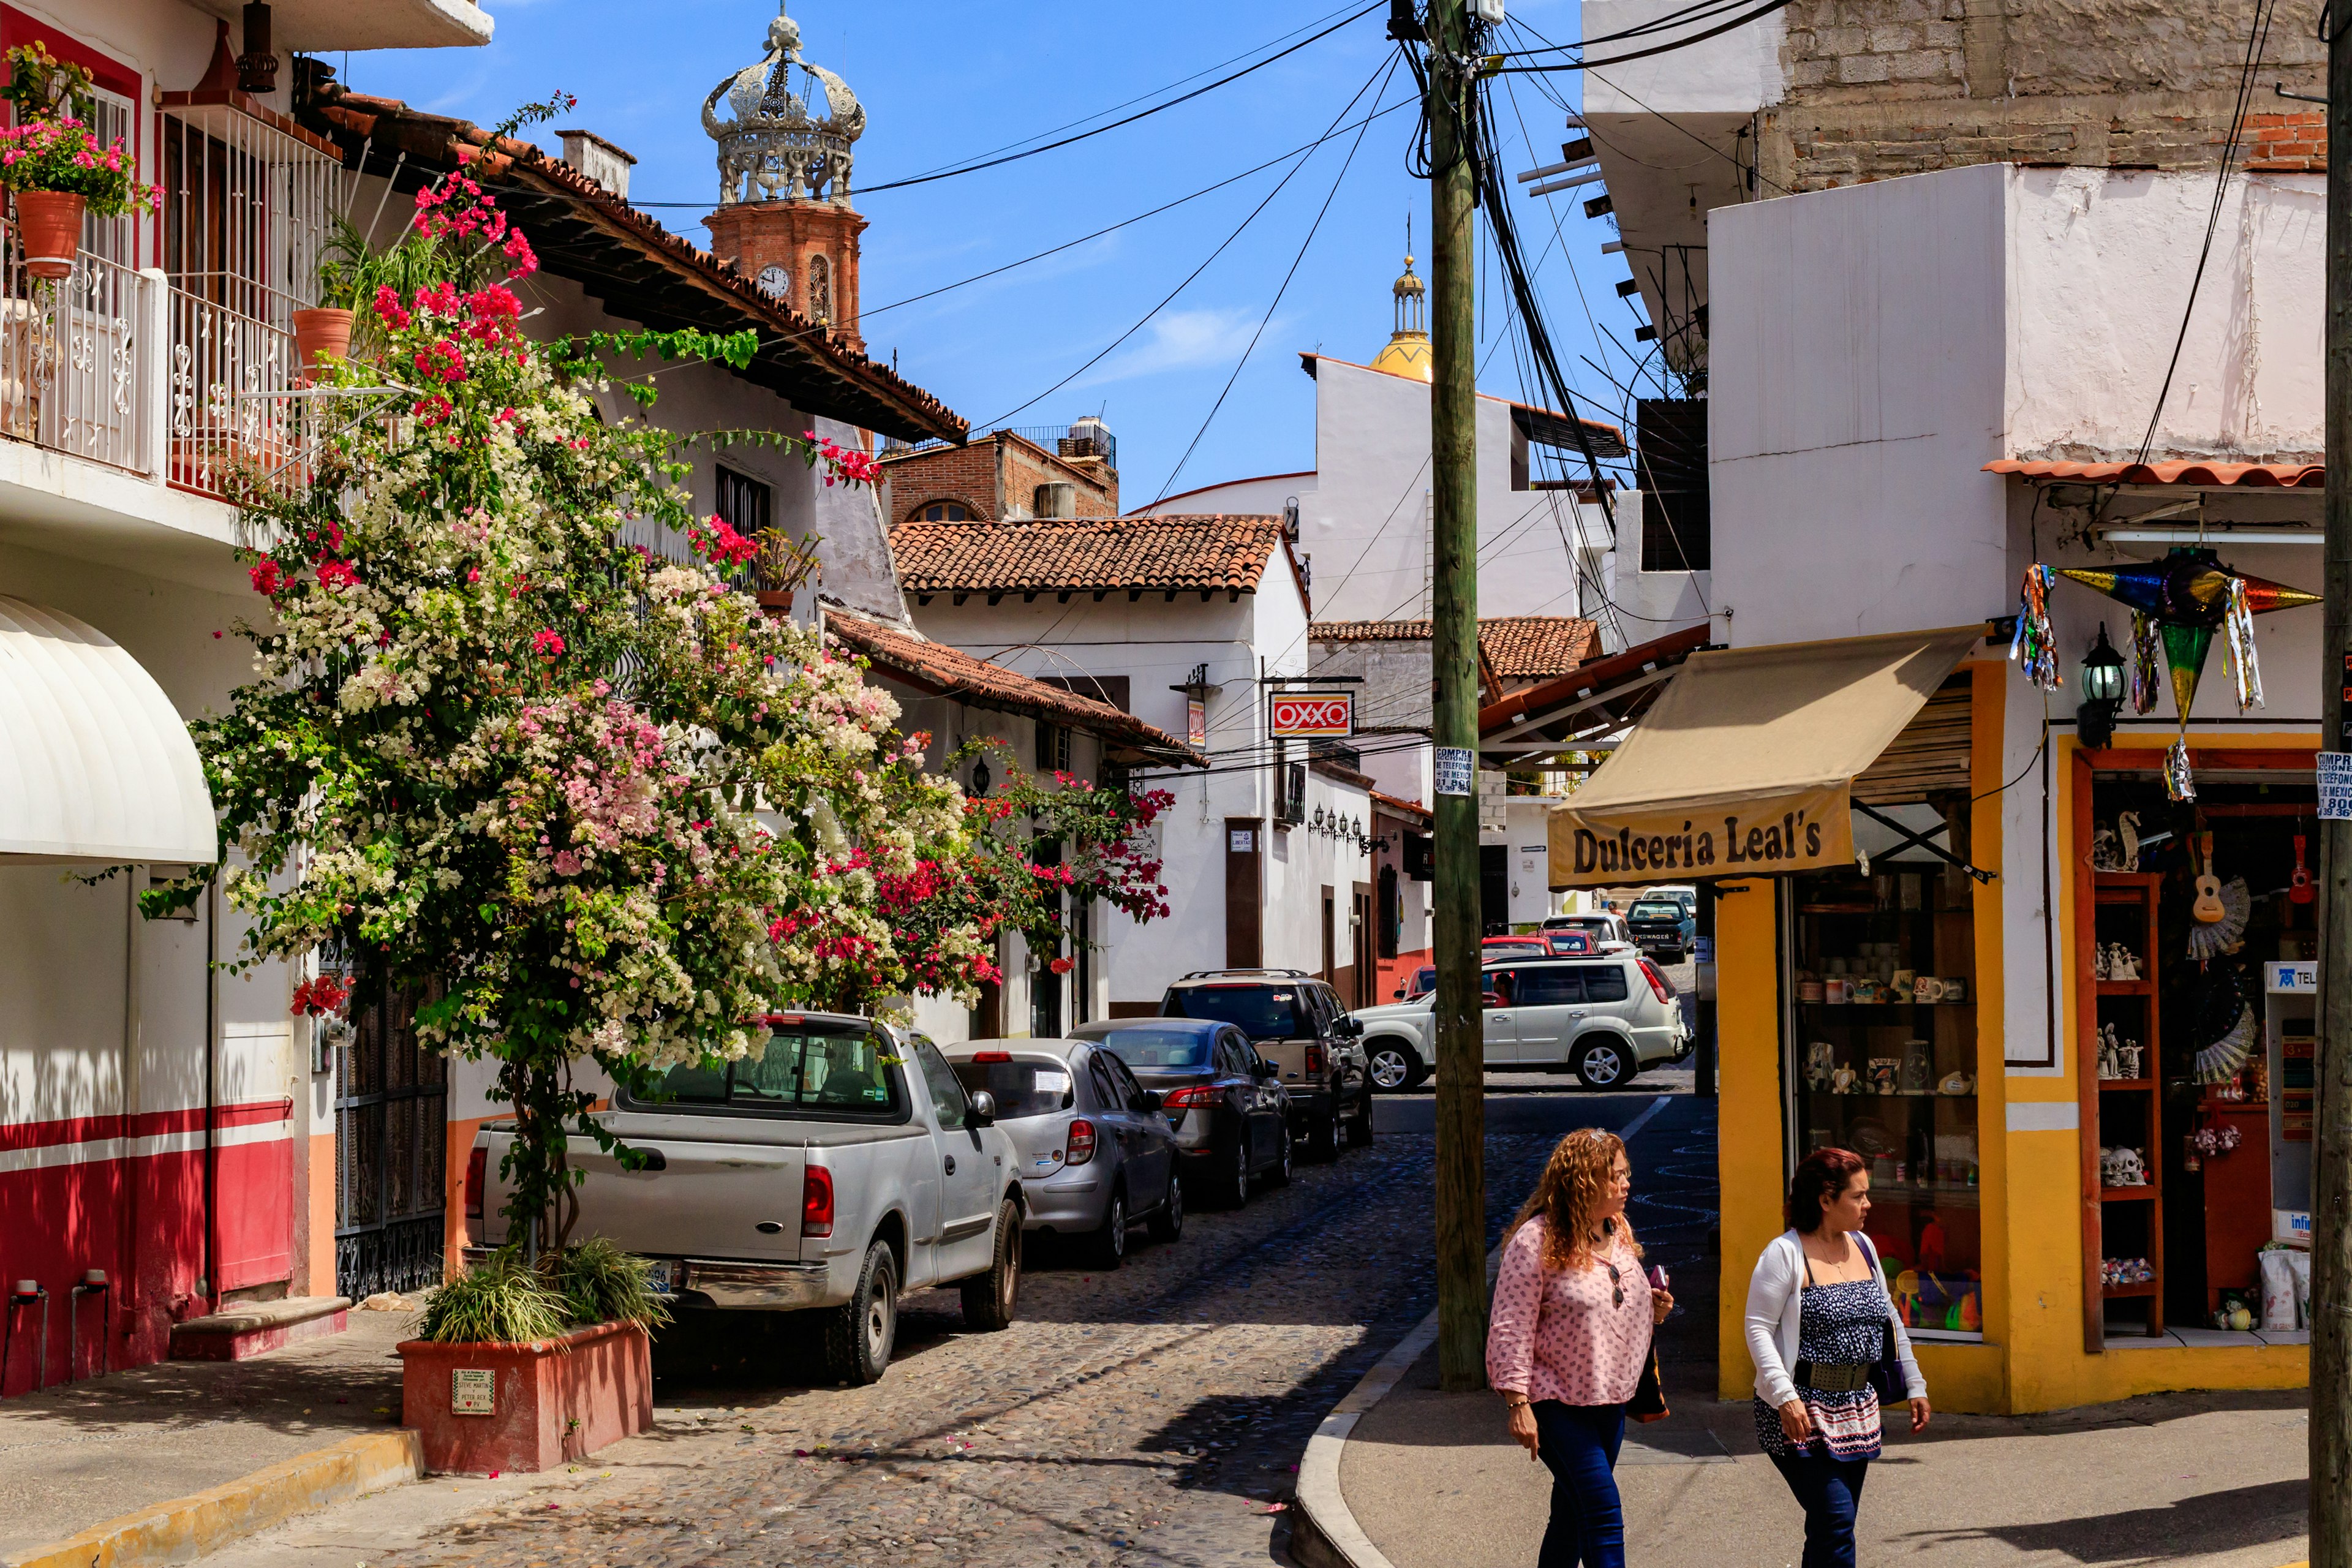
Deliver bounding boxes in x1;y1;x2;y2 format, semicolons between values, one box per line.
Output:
1487;1126;1675;1568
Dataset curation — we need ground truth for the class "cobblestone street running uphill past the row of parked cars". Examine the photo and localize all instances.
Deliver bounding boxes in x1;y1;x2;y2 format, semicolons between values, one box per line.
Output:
216;1074;1713;1568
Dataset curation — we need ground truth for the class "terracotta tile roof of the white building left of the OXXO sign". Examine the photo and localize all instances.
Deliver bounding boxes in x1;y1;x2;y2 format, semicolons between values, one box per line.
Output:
889;515;1286;595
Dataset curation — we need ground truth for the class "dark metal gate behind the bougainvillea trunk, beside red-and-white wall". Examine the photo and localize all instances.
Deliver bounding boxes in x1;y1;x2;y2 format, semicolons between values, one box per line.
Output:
334;990;449;1300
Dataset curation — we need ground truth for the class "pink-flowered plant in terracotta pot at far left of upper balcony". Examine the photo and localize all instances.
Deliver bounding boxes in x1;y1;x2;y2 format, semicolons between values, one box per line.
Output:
0;37;162;282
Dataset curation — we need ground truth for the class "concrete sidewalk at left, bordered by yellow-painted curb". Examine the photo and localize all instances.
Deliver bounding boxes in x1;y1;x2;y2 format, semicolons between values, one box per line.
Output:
0;1312;417;1561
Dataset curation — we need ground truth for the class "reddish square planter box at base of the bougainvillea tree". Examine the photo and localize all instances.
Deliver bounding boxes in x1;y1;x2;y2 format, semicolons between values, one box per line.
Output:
400;1324;654;1476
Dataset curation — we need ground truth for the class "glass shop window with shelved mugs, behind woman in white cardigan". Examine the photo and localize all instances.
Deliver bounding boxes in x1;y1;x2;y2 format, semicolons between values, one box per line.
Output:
1783;865;1985;1340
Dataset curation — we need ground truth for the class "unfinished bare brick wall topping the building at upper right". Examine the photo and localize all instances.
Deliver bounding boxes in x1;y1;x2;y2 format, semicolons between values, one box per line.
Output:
1757;0;2324;190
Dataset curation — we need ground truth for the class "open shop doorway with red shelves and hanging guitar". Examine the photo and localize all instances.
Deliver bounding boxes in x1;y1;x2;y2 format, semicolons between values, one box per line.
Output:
2077;755;2316;1338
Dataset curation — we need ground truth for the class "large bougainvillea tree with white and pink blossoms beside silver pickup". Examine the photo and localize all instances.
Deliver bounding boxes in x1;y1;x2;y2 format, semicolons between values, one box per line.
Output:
176;144;1164;1243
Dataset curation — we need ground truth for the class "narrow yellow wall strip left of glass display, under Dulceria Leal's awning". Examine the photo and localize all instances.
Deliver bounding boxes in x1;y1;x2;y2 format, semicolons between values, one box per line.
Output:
1714;877;1785;1399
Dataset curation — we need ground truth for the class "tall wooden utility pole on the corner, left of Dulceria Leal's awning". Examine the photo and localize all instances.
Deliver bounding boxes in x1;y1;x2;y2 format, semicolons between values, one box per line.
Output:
1425;0;1487;1389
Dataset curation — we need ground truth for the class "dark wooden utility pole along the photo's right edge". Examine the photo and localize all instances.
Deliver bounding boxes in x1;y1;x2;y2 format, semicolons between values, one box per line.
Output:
2310;2;2352;1568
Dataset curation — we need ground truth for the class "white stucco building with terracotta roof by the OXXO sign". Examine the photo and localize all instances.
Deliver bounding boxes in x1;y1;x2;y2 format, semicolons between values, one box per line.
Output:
891;515;1376;1025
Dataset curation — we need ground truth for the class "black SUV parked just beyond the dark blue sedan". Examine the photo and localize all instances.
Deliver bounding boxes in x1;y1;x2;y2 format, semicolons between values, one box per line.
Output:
1159;968;1371;1159
